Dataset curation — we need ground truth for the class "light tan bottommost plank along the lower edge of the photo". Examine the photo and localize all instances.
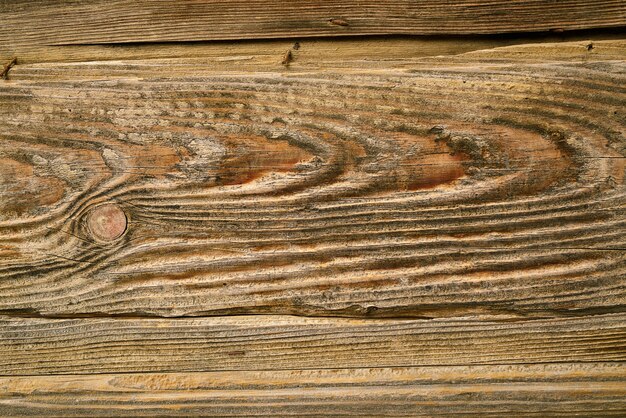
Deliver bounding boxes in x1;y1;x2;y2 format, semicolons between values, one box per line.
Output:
0;363;626;417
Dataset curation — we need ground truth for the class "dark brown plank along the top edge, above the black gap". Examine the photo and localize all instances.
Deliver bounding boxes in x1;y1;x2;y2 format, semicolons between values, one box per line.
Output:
0;0;626;47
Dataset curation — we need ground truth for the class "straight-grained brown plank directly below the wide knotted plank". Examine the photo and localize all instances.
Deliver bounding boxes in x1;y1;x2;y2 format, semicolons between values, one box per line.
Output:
0;314;626;375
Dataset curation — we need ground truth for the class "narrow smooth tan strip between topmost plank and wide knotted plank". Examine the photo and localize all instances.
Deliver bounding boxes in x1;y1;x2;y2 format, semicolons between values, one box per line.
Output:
0;35;625;67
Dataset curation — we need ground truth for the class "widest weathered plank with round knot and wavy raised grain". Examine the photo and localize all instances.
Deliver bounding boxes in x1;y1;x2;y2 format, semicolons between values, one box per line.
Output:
0;41;626;318
